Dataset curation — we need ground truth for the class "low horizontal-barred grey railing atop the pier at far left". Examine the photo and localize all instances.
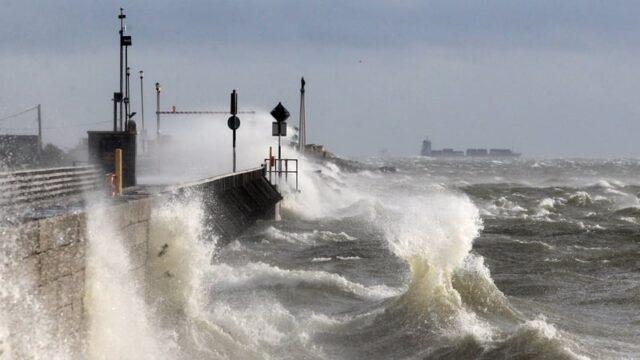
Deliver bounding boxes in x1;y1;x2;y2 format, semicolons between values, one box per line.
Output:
0;166;103;206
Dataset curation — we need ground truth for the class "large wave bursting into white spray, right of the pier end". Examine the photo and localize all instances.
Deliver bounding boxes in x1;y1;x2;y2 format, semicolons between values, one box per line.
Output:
278;161;587;358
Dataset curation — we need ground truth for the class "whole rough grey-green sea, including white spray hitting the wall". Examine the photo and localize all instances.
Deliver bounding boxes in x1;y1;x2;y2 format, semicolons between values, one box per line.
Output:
0;157;640;359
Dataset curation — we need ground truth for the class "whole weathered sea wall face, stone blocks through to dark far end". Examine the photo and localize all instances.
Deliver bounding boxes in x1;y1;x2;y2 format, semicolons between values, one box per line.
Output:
0;169;281;358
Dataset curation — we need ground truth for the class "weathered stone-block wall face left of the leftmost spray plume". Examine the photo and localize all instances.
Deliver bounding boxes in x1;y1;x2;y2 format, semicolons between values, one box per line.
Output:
0;213;86;358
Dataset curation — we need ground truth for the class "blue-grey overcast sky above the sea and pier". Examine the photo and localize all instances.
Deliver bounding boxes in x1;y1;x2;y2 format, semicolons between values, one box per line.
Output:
0;0;640;157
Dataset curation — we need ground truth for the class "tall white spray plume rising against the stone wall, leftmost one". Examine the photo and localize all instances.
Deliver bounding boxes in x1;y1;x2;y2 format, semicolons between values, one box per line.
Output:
85;207;178;359
